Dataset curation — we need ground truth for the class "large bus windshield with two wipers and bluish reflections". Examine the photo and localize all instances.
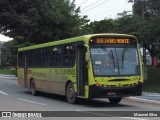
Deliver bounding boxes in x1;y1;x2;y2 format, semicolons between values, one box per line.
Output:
91;45;140;76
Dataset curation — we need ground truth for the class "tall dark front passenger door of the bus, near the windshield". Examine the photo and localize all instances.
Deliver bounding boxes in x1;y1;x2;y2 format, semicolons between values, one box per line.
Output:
76;42;88;96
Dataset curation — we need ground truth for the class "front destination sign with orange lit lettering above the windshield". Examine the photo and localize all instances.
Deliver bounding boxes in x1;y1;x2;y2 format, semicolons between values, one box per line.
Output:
90;37;136;44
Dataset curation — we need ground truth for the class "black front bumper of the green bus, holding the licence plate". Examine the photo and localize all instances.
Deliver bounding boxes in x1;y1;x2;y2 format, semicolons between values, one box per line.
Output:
89;83;143;98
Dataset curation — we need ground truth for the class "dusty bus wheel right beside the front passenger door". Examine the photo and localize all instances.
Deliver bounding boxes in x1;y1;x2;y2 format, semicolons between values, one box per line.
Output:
66;82;77;104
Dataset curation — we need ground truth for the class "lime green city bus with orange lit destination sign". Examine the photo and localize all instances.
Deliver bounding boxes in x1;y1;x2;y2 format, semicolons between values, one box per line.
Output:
17;33;143;104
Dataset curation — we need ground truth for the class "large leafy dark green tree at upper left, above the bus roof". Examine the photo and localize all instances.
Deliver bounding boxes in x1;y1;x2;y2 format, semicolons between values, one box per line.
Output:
0;0;87;44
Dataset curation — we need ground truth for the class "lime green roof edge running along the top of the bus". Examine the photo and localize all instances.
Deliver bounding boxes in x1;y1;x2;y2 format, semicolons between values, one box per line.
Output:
18;33;135;51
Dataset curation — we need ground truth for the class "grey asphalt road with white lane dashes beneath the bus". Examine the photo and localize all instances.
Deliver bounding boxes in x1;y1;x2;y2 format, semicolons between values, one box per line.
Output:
0;77;160;120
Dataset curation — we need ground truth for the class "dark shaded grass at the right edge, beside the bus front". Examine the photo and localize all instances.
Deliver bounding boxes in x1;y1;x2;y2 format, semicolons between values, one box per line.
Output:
143;66;160;93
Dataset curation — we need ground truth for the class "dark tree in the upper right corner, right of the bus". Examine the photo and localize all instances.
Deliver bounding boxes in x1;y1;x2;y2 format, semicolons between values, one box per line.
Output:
129;0;160;57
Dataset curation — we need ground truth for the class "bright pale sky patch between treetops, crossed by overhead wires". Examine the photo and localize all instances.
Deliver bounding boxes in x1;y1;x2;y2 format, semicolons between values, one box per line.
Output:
75;0;132;21
